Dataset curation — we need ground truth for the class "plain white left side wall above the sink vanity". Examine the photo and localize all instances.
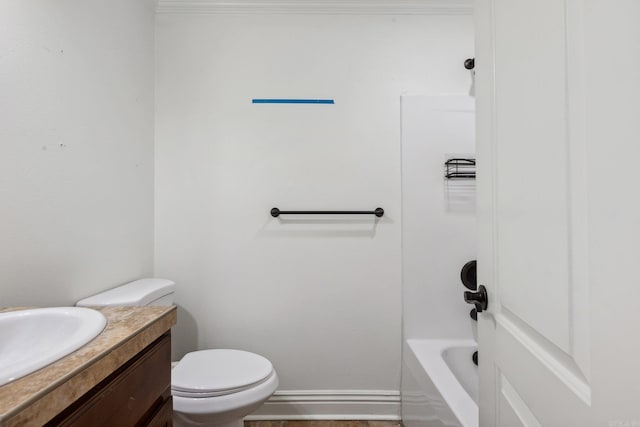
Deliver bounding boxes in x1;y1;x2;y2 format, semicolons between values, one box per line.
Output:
0;0;155;305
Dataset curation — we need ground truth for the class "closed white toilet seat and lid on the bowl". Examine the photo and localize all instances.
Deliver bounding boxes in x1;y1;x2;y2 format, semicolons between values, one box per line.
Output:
171;349;274;398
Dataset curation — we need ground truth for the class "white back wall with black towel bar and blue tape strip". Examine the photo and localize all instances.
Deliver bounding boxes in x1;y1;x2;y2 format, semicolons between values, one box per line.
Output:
155;2;473;418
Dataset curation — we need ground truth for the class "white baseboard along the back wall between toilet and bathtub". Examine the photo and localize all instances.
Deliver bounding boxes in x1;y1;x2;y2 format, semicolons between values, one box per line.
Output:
245;390;400;421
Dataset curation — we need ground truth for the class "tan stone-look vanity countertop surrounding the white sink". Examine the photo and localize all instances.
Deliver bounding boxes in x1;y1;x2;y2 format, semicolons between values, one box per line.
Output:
0;306;176;427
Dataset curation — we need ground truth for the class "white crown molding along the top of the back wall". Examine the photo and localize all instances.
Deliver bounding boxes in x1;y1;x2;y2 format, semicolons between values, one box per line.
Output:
156;0;473;15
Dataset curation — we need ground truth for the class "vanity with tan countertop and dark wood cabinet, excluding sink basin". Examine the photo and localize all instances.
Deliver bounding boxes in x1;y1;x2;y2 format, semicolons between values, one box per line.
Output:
0;306;176;427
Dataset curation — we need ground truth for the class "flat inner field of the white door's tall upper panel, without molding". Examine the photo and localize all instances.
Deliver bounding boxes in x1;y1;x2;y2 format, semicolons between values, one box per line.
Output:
495;0;571;353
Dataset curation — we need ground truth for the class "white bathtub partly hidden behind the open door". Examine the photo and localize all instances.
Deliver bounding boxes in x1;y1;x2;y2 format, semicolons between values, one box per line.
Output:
402;339;478;427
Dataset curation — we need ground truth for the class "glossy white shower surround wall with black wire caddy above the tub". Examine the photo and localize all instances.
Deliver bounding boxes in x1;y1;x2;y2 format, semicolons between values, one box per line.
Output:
402;95;476;339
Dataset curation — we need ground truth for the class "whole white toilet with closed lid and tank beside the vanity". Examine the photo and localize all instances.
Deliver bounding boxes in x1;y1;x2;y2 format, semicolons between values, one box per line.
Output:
76;279;278;427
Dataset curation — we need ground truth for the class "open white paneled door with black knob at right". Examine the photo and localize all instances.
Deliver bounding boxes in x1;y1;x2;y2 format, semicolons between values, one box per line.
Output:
475;0;640;427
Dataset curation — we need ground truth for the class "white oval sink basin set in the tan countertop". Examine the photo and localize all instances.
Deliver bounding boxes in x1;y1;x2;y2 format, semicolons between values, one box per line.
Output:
0;307;107;386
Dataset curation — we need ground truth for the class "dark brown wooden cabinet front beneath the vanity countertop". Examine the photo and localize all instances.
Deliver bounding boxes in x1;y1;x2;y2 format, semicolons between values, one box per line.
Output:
47;332;173;427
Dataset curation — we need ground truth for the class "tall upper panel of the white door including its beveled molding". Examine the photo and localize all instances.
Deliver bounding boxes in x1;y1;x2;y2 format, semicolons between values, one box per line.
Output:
494;0;590;394
